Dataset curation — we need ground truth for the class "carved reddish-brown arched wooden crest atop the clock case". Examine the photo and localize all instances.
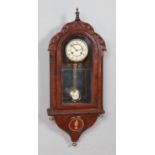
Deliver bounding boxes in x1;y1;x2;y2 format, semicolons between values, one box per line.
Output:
48;20;106;55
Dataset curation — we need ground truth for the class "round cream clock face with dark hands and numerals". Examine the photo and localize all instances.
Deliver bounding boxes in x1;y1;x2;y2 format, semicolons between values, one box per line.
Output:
65;39;88;62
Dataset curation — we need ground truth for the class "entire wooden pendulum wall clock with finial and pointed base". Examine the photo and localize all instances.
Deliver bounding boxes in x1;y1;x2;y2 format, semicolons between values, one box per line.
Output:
47;9;106;145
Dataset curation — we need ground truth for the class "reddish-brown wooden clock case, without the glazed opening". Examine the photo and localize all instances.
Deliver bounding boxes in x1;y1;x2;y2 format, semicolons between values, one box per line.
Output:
47;10;106;142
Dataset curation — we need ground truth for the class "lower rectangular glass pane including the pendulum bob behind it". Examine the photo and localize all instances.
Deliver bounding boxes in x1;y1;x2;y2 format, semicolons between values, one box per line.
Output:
62;68;91;104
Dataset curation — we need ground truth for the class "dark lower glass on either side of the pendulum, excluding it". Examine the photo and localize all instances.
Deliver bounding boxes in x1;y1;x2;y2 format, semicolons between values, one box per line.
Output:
62;68;91;103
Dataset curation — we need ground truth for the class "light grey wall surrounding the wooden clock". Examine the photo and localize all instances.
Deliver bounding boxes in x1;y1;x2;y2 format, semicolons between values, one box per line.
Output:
38;0;116;155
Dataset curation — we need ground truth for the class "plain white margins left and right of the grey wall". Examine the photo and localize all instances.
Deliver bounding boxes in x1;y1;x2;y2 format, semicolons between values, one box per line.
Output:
0;0;155;155
